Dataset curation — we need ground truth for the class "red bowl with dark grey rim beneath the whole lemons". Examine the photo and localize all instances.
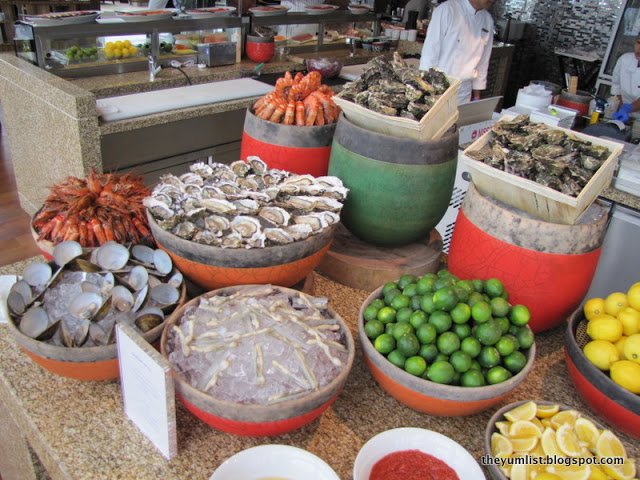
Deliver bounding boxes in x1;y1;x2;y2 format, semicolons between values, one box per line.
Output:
564;308;640;438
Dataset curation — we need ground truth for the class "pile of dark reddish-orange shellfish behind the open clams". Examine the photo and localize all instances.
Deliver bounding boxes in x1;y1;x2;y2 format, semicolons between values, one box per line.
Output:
32;172;153;247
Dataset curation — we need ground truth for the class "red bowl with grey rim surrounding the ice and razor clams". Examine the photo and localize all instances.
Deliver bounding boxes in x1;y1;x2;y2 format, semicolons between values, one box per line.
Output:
160;285;355;436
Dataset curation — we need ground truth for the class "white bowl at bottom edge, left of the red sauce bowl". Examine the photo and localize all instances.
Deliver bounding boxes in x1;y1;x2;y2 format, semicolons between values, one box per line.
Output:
209;445;340;480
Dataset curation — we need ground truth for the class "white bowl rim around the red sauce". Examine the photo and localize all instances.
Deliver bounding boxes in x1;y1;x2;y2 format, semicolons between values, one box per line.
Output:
353;428;485;480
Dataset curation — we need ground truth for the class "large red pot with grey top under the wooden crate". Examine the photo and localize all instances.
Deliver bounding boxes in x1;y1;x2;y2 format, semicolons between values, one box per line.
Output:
449;185;609;332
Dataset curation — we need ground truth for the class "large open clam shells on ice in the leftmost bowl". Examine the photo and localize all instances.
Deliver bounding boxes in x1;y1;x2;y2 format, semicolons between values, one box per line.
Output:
7;241;183;347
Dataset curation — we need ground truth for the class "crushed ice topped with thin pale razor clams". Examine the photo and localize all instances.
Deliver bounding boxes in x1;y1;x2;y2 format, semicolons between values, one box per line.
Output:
165;285;349;405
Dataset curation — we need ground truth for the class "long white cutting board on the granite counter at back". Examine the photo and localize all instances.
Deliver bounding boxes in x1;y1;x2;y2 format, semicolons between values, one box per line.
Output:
96;78;273;122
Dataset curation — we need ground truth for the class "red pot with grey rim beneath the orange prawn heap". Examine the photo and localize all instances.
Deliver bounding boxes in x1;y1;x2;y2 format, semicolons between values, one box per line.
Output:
240;108;336;177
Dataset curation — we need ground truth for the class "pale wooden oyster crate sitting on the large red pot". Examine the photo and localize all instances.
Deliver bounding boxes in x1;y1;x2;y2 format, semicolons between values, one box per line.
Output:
462;115;623;225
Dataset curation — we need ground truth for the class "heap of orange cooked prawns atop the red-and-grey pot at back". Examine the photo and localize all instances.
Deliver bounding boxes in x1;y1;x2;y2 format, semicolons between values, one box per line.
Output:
253;72;340;127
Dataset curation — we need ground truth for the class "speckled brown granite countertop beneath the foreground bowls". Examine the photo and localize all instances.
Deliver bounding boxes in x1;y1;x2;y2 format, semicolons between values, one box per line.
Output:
0;265;640;480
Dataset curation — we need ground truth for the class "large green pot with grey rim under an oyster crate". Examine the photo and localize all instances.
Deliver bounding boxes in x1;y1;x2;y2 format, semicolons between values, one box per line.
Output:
329;115;458;246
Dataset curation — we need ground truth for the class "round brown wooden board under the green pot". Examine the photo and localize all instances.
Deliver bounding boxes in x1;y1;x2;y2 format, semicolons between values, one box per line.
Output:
317;224;442;292
